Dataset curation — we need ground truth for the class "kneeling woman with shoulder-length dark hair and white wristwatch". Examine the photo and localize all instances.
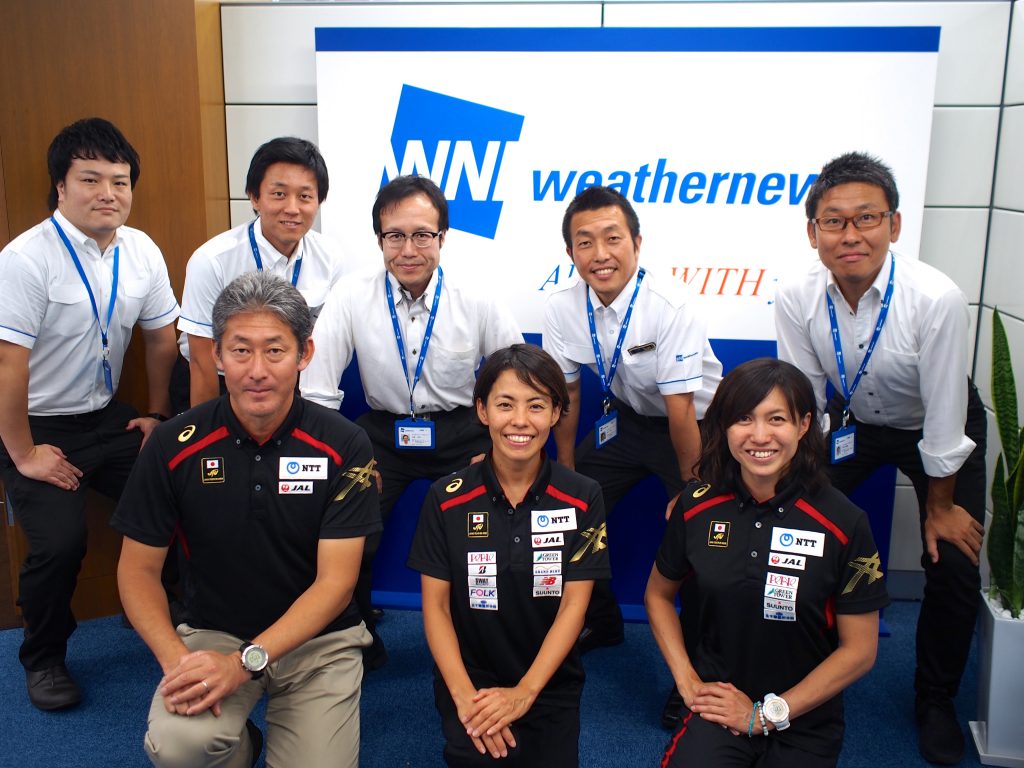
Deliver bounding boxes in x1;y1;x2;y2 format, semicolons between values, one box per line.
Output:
644;357;889;768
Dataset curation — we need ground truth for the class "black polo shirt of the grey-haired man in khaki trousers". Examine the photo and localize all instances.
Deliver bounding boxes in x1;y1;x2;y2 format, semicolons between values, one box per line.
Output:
111;395;381;638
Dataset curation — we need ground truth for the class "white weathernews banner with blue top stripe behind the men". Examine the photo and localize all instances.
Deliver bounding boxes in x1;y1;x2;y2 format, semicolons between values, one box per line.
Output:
316;27;939;349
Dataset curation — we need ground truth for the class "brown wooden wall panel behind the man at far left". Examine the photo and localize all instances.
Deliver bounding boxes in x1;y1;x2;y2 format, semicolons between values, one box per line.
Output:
0;0;228;623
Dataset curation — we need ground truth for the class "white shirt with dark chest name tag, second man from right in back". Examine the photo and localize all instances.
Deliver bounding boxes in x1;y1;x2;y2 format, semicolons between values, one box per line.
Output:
544;271;722;420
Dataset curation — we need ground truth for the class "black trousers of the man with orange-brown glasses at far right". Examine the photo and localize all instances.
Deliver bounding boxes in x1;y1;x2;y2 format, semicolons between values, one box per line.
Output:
828;381;987;698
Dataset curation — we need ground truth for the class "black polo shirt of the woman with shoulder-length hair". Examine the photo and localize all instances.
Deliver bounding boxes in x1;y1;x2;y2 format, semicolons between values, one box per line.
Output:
656;481;889;756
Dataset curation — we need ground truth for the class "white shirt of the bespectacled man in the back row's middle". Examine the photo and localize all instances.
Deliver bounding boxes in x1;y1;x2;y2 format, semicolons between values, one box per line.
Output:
299;267;522;414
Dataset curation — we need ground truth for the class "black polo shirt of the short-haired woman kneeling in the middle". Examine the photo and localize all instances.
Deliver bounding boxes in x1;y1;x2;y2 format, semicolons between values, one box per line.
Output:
409;455;611;707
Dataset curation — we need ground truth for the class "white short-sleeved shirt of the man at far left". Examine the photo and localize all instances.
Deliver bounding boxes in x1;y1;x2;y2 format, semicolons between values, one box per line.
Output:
0;211;178;416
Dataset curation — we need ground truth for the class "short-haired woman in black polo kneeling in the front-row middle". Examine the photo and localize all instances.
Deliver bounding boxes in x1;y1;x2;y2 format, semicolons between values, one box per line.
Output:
409;344;608;768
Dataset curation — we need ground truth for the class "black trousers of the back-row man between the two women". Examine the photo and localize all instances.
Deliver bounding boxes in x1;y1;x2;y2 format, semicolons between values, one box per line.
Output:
575;399;685;634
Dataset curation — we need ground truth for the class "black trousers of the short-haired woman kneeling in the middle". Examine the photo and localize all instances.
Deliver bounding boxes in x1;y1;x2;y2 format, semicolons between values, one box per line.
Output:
434;676;580;768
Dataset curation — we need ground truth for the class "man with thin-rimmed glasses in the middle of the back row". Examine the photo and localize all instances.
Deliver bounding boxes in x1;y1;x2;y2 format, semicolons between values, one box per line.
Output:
300;176;522;669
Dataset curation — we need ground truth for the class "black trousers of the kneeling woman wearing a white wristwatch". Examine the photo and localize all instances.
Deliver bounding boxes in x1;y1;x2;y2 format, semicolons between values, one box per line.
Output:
662;707;839;768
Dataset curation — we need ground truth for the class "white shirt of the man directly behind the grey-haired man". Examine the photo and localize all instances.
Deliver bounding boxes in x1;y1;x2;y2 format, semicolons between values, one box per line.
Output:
178;218;341;359
